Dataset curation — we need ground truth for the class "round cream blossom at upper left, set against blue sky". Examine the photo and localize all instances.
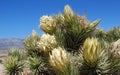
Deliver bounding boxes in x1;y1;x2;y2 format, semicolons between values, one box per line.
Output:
40;16;56;34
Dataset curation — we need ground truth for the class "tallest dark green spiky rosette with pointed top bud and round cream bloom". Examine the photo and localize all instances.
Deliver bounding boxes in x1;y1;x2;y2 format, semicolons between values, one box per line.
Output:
40;5;99;52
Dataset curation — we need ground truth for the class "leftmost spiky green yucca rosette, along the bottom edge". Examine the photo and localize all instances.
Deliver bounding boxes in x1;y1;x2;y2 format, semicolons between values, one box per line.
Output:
4;56;24;75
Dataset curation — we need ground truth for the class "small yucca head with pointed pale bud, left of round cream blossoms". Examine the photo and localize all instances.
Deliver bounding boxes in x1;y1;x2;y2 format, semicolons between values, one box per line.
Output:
24;30;42;56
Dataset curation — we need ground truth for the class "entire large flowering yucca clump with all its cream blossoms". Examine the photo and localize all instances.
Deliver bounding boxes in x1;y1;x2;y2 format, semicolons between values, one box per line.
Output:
19;5;120;75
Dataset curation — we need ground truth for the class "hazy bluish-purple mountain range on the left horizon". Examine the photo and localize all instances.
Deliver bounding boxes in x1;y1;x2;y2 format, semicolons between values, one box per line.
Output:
0;38;24;50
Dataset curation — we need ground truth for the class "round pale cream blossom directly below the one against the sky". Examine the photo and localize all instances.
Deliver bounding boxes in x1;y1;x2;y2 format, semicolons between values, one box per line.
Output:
38;34;57;52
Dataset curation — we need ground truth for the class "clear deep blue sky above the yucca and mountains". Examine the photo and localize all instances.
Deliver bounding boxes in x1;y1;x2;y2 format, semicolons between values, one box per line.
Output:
0;0;120;38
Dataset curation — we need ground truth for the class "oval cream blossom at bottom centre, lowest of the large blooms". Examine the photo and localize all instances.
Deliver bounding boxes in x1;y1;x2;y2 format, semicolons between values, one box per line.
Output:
50;47;69;72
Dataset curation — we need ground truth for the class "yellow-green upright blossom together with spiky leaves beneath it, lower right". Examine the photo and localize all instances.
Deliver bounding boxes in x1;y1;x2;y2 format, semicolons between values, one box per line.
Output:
79;38;120;75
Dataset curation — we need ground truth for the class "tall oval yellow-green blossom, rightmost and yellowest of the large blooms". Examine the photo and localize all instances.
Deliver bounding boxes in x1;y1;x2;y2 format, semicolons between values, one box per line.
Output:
83;38;101;66
